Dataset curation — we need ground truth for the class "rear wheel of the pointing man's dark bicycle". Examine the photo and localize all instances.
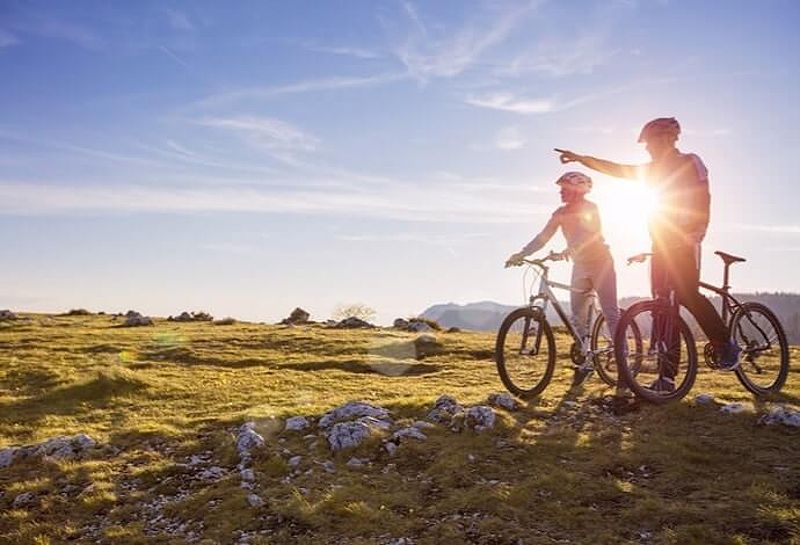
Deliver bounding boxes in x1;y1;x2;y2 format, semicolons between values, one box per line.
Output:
731;302;789;396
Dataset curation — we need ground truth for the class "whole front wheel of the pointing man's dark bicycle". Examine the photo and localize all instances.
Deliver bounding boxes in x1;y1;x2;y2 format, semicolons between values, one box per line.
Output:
614;301;697;404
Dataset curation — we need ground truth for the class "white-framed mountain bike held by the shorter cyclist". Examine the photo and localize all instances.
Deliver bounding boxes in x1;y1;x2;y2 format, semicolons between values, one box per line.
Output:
495;252;641;398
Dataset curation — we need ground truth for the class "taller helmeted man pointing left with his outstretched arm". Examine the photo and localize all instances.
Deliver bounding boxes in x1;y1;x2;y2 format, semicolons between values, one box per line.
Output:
555;117;741;391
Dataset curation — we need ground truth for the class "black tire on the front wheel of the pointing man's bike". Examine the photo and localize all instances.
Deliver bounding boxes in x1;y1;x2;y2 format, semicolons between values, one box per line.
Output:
614;300;697;405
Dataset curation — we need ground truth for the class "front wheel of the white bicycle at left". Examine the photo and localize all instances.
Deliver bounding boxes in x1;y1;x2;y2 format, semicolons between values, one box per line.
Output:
495;308;556;398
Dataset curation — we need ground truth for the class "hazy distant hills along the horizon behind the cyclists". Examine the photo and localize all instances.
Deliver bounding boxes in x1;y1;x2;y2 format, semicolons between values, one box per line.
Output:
421;292;800;344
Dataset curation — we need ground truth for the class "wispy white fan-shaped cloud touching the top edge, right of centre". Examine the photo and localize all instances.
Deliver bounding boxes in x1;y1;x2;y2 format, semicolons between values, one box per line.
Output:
394;2;540;82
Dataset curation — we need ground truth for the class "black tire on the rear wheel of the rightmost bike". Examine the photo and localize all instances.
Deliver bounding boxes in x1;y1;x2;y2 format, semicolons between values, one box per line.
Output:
730;302;789;396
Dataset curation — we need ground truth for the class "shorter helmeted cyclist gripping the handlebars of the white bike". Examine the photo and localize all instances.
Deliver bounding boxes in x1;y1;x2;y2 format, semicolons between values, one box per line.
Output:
506;172;619;385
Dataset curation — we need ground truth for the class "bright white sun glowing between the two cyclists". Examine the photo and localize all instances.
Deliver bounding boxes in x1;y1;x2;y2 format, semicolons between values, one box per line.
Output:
588;180;658;254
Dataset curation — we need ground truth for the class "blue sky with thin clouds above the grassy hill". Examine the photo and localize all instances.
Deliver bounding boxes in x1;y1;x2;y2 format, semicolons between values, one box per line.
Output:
0;0;800;323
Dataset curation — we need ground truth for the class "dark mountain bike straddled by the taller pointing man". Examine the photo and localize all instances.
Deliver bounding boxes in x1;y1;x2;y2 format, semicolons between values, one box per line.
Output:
614;251;789;403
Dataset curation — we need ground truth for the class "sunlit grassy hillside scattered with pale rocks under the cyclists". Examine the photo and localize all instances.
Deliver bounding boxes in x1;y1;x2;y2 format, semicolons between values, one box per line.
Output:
0;315;800;545
